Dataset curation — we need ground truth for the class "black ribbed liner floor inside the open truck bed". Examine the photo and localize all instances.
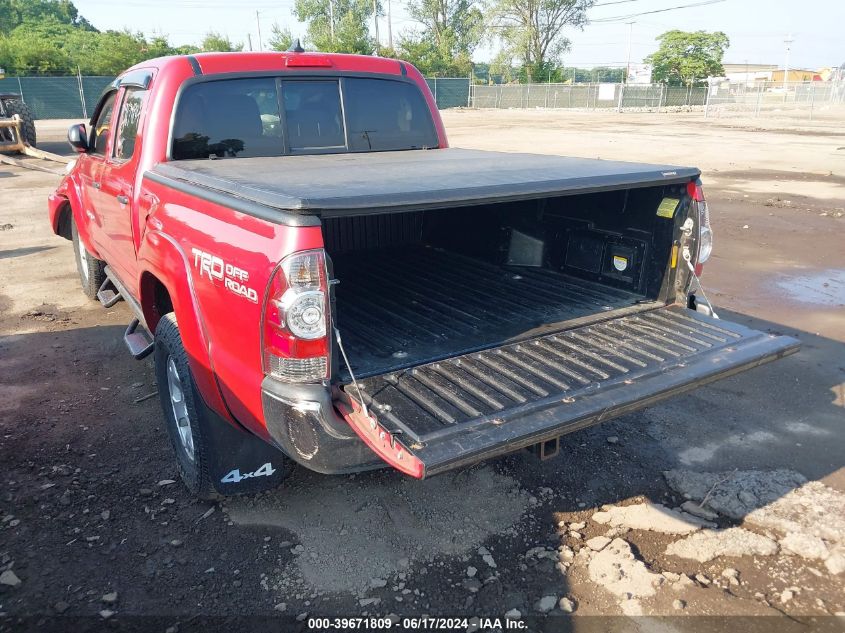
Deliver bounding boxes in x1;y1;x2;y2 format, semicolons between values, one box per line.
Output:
334;247;659;380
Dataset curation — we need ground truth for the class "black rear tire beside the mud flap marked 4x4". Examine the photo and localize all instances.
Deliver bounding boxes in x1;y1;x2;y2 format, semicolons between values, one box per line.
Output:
155;312;219;501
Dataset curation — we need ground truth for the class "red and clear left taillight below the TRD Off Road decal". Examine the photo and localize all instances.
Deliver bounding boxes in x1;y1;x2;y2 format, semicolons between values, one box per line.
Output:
261;249;330;382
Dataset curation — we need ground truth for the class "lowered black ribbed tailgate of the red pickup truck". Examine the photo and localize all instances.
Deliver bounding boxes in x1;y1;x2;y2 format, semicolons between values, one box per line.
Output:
345;306;799;476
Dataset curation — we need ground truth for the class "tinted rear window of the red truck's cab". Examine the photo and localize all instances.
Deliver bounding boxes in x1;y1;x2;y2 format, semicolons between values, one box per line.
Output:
171;77;438;160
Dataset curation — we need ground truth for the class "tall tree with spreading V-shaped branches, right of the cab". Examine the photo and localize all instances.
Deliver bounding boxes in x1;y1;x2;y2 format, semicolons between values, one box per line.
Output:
489;0;595;81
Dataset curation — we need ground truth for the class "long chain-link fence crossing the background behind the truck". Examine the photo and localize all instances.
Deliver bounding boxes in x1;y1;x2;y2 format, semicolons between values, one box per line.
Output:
0;77;845;119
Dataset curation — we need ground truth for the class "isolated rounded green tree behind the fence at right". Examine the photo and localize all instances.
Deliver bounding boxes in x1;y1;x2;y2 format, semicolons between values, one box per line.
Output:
643;30;730;86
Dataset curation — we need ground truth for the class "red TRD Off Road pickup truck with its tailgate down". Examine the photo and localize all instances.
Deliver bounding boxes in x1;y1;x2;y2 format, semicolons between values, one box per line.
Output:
49;50;798;498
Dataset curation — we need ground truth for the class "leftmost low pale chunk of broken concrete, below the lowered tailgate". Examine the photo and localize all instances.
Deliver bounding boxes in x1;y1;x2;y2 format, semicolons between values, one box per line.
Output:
588;538;663;598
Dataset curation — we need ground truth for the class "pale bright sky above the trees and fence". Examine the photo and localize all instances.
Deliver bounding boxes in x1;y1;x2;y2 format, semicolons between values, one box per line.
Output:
74;0;845;70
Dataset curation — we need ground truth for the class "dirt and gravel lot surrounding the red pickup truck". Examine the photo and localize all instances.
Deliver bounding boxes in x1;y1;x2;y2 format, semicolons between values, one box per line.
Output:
0;111;845;631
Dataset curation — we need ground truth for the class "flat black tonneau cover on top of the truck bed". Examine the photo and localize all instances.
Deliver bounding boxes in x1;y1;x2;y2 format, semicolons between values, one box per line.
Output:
146;149;700;217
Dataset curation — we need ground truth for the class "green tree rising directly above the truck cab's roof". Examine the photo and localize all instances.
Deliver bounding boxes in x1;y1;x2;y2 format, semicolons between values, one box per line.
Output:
294;0;376;55
